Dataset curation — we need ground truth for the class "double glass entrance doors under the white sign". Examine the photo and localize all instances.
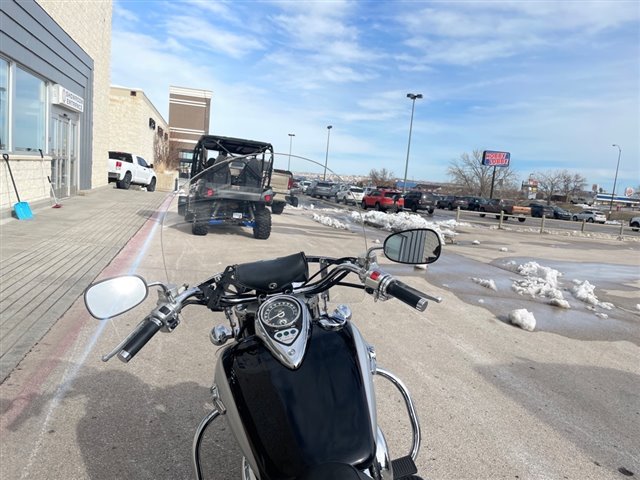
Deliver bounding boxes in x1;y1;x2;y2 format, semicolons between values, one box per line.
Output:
49;106;79;198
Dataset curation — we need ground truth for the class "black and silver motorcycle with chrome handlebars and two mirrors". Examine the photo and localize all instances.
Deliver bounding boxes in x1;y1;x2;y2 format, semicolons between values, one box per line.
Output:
84;153;442;480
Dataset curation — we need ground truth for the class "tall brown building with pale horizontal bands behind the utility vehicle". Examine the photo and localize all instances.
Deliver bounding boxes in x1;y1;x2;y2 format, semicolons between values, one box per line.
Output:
169;86;212;177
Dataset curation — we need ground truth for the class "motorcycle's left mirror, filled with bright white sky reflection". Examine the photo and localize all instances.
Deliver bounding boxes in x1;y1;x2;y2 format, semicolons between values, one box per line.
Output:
84;275;149;320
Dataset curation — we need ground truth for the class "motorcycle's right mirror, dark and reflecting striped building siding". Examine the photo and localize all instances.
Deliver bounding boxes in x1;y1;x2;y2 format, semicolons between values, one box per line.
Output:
384;228;442;265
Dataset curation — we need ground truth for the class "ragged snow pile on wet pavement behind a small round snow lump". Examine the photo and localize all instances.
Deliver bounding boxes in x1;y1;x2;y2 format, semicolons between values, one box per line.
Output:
505;261;571;308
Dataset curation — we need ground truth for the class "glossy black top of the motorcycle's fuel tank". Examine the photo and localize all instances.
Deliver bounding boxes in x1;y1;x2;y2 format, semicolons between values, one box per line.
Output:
222;324;375;480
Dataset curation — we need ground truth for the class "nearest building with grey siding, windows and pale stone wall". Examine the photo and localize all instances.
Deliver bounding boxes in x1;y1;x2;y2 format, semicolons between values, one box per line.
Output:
0;0;112;215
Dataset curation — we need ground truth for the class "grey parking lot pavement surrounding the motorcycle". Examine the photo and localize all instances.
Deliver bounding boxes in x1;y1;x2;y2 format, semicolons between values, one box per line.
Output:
0;190;640;480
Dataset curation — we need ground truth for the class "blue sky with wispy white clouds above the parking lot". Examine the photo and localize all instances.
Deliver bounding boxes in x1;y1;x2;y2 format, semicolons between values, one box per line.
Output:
111;0;640;193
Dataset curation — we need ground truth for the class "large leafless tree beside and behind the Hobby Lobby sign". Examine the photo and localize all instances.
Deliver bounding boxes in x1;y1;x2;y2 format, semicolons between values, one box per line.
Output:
447;150;518;197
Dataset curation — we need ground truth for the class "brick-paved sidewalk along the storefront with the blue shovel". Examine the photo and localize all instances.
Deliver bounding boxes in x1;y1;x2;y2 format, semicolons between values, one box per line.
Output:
0;186;167;383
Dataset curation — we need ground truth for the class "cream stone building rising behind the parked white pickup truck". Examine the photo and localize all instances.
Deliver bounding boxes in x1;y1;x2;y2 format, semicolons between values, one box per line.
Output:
110;86;169;170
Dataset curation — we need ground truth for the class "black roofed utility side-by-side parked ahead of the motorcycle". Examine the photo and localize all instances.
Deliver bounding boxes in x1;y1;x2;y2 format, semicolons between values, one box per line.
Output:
178;135;273;239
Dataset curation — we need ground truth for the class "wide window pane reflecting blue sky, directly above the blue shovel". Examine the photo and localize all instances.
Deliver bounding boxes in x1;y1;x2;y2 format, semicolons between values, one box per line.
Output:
12;67;46;151
